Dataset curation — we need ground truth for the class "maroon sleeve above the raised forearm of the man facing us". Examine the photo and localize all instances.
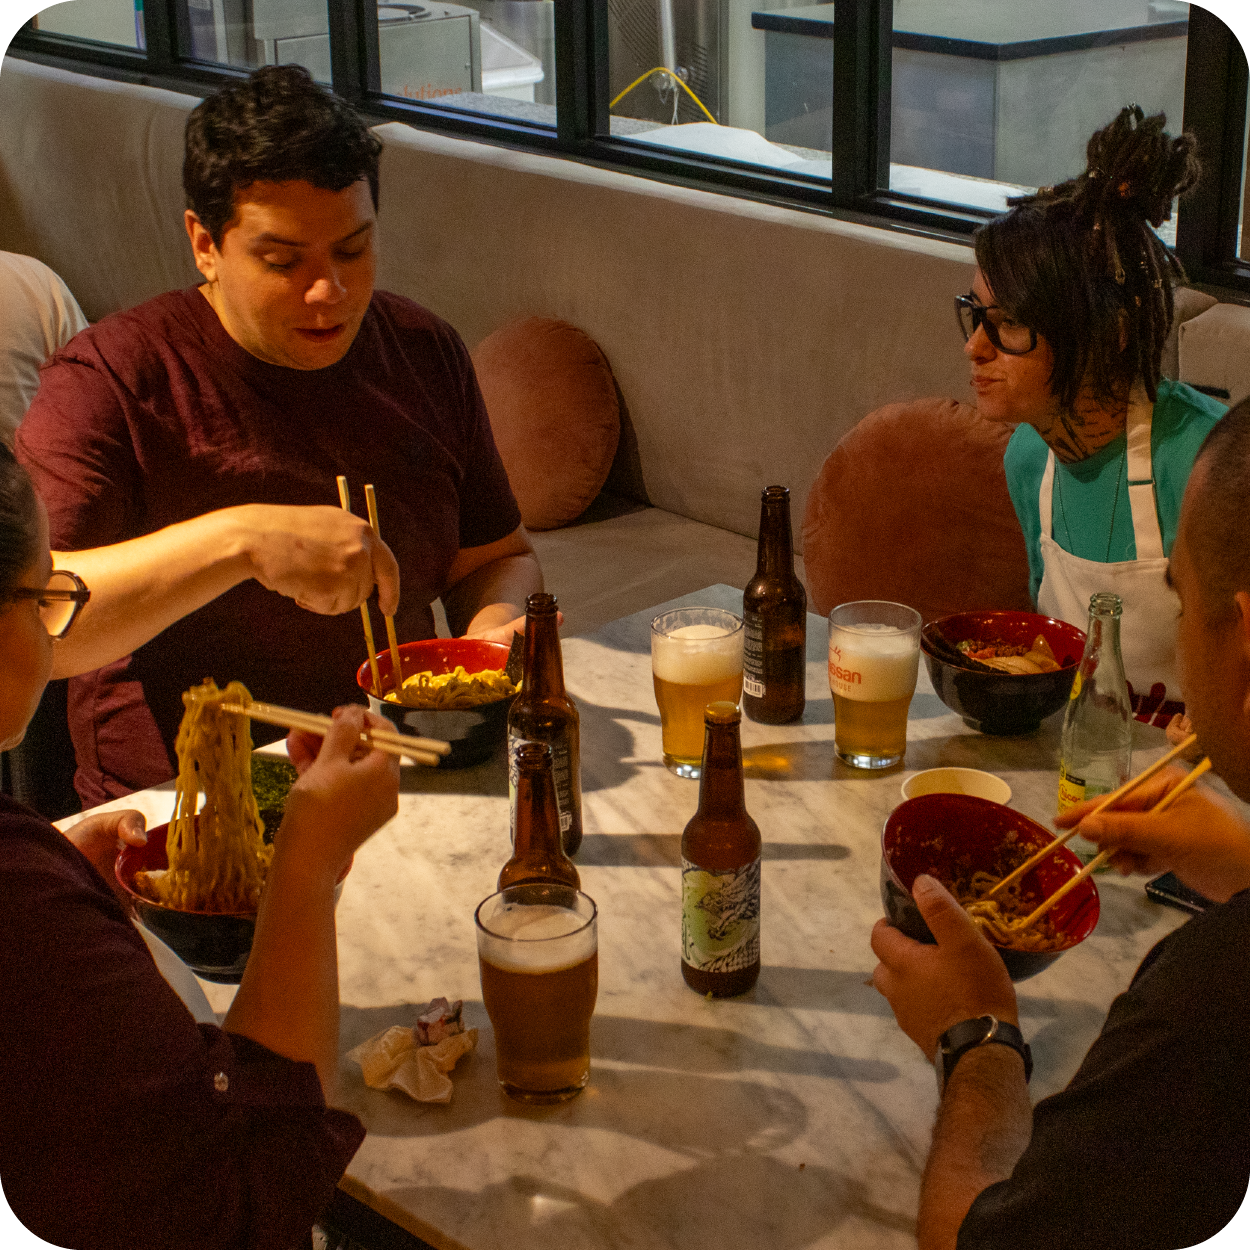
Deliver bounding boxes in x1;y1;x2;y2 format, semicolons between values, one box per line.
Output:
16;350;143;551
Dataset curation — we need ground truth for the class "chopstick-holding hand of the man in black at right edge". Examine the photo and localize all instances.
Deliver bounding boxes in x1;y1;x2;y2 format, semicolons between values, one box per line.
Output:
1055;768;1250;903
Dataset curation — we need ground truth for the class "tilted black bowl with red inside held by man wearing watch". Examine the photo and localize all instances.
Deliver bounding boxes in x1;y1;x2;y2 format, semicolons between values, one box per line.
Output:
881;794;1099;981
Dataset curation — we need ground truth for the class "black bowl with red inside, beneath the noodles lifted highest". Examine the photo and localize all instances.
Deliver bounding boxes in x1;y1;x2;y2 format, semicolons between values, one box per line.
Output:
114;824;351;985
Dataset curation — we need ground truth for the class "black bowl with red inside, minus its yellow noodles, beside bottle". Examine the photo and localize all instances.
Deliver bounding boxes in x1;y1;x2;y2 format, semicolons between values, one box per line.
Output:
356;638;516;769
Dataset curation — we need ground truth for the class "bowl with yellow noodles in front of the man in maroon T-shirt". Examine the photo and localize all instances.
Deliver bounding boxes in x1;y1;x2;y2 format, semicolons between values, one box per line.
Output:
356;638;518;769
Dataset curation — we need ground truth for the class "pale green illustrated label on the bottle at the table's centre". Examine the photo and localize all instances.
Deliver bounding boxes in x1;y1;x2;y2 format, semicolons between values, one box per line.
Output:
681;858;760;973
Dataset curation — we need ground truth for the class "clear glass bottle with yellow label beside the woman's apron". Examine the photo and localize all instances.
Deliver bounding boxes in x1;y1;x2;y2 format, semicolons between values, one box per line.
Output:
1059;593;1133;861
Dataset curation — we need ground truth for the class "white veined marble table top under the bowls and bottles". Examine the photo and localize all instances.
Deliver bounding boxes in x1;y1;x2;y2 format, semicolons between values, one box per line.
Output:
63;586;1184;1250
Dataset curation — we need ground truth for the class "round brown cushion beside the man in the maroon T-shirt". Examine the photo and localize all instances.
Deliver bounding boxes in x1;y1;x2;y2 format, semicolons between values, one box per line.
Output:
473;316;620;530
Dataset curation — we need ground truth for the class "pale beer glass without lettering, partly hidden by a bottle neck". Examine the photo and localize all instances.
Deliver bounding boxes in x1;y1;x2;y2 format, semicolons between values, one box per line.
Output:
651;608;743;778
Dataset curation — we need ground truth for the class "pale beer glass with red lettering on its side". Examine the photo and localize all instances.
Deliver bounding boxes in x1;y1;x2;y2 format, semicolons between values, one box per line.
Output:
829;599;921;769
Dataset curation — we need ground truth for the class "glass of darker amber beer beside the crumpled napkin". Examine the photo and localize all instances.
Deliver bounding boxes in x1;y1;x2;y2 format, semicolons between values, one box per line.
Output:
474;883;599;1105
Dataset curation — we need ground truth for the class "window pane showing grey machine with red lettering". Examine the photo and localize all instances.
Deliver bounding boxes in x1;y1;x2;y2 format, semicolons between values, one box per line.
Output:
378;0;555;128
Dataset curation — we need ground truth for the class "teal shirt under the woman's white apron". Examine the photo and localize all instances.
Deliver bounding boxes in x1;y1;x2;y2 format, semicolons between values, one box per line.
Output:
1003;378;1228;603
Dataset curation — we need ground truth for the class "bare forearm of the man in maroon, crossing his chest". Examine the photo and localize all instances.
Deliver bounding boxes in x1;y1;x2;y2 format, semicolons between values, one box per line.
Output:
53;505;263;678
